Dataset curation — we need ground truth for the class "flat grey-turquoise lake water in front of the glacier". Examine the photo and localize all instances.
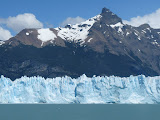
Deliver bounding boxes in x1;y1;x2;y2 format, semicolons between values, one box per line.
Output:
0;104;160;120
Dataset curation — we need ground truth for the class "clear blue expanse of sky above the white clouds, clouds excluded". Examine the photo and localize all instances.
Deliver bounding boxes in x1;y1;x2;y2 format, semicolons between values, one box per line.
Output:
0;0;160;26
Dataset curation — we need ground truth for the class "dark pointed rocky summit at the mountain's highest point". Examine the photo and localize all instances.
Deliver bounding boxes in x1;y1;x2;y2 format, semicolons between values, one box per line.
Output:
101;8;122;25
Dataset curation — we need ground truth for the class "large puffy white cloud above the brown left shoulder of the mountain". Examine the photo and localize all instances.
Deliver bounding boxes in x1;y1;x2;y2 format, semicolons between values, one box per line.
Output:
0;13;43;32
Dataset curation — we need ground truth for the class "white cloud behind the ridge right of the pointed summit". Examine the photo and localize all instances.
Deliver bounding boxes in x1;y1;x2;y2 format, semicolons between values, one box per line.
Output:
123;8;160;28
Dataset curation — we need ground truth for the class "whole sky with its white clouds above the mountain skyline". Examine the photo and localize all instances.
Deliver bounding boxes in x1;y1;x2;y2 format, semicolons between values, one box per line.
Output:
0;0;160;40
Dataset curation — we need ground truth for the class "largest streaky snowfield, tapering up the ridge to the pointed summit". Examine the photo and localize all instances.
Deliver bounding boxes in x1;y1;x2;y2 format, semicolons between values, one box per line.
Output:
56;15;102;44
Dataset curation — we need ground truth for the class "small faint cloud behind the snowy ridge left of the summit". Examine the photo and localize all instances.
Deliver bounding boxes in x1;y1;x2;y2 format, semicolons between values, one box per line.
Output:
61;16;85;26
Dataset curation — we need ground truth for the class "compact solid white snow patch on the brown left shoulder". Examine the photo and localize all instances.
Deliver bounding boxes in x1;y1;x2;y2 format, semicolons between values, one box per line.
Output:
37;28;57;46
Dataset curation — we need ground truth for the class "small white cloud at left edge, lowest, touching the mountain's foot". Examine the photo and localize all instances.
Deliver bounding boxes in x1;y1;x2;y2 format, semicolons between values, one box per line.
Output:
0;27;12;40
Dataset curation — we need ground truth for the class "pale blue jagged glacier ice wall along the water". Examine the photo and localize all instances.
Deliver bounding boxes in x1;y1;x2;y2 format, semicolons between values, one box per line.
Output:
0;75;160;104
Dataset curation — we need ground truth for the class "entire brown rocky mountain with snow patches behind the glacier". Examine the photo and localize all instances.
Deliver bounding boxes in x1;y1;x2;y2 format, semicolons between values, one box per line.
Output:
0;8;160;80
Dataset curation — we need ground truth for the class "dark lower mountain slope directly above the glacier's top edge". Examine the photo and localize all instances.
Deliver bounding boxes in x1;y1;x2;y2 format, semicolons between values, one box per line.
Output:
0;44;158;79
